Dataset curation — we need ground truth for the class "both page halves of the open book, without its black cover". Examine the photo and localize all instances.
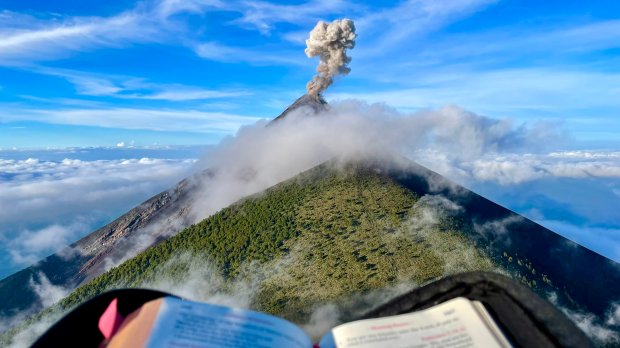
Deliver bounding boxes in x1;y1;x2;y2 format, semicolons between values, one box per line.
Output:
108;297;510;348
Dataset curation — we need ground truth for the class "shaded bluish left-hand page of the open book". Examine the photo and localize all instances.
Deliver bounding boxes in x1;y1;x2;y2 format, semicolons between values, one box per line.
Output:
146;297;312;348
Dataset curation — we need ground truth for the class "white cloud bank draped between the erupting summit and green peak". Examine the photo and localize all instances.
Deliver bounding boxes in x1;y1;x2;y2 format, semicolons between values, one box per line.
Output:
183;101;556;224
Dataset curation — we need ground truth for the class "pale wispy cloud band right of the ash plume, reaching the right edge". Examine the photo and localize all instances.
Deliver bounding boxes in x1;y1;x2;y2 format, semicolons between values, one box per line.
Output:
331;67;620;118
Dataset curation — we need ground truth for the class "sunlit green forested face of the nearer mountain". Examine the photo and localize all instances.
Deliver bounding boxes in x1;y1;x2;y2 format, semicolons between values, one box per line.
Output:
60;165;492;321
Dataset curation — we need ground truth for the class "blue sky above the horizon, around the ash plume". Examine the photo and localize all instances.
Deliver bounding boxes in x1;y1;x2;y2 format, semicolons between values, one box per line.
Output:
0;0;620;148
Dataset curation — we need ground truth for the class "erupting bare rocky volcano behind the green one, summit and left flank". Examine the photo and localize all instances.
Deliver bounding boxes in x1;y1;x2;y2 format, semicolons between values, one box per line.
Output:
0;94;328;317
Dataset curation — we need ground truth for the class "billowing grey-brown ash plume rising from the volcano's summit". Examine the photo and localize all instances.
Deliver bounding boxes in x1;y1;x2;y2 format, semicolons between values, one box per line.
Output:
305;19;357;96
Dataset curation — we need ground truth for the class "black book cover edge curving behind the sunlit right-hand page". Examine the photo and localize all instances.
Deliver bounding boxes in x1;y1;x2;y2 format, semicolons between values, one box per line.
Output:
361;272;592;348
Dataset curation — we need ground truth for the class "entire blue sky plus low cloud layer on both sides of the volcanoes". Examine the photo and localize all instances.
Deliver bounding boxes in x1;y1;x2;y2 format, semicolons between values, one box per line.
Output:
0;0;620;277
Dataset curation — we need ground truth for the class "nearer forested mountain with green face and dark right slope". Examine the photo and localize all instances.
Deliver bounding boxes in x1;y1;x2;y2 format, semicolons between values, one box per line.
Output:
6;161;620;346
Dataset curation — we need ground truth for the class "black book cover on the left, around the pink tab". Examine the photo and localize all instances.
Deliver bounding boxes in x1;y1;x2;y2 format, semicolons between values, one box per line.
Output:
32;289;174;348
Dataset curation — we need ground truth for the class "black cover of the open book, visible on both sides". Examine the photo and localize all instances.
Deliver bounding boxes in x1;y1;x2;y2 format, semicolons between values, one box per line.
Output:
33;272;592;348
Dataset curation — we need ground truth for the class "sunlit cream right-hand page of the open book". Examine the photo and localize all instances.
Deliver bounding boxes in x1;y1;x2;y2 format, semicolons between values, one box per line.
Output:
321;297;509;348
